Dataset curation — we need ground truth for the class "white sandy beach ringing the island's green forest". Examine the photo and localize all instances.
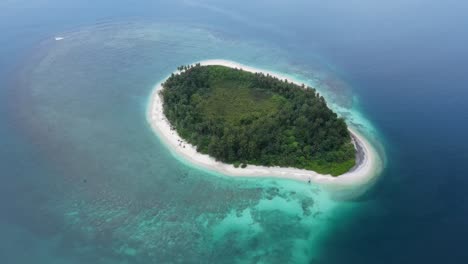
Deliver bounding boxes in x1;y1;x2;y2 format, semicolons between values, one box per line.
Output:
147;60;382;192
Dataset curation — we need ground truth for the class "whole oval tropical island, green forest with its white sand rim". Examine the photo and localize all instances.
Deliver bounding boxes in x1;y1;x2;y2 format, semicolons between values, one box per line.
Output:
147;60;381;190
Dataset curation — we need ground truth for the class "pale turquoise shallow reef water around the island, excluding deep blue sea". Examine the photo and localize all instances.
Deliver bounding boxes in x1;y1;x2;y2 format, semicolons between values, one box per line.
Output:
5;22;382;263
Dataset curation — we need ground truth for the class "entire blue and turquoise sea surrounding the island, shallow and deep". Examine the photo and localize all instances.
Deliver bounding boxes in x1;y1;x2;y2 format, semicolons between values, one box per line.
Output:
0;0;468;264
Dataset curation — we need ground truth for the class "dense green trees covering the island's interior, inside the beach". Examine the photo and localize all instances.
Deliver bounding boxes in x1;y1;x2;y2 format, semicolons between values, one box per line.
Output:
161;64;355;175
